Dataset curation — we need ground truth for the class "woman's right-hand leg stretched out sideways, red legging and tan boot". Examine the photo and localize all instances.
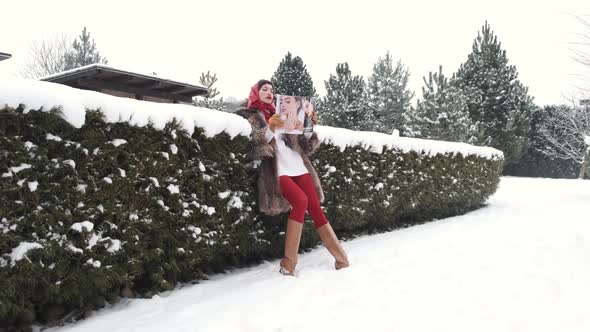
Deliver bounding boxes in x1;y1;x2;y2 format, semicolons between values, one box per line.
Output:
293;174;350;270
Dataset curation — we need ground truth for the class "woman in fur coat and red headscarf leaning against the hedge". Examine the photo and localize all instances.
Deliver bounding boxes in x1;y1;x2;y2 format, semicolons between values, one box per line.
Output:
236;80;349;275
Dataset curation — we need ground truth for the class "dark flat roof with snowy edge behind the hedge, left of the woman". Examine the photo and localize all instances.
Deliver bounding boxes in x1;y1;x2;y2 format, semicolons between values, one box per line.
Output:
41;64;208;102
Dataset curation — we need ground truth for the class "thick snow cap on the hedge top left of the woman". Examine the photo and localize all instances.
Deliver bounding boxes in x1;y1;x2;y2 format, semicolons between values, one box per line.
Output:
0;78;251;137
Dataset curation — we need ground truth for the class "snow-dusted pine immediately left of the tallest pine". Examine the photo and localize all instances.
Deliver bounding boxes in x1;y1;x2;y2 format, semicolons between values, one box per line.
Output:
404;66;477;142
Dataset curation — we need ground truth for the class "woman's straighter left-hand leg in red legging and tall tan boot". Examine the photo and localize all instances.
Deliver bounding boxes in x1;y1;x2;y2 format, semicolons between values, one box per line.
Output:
279;176;307;275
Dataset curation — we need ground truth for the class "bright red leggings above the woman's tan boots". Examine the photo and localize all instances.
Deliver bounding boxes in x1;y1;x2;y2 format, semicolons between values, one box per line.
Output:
279;173;328;228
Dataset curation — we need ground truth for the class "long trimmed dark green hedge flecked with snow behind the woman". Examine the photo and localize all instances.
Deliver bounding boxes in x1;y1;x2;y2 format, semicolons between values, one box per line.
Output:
0;108;503;327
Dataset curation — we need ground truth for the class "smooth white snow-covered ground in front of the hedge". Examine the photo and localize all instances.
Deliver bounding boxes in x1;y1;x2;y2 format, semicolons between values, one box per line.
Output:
49;177;590;332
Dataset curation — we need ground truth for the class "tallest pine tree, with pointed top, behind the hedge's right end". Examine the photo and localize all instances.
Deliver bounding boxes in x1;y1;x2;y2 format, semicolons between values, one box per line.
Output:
453;22;535;165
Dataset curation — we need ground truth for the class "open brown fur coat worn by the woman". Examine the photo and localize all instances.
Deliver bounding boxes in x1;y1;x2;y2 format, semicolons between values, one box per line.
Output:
236;108;324;216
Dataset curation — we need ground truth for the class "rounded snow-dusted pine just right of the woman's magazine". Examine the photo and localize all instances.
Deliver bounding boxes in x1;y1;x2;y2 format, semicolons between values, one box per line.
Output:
319;63;374;130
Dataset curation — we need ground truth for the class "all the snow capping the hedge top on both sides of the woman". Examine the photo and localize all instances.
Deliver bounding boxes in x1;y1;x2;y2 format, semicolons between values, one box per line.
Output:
0;78;504;159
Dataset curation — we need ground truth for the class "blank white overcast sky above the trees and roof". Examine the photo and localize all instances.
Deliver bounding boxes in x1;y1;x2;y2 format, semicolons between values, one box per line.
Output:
0;0;590;105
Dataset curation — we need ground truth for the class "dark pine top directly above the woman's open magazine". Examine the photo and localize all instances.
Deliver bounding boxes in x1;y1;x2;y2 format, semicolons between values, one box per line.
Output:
271;52;316;96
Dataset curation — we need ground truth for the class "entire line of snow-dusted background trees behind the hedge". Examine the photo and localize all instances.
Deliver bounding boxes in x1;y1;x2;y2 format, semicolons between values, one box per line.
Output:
22;17;590;178
